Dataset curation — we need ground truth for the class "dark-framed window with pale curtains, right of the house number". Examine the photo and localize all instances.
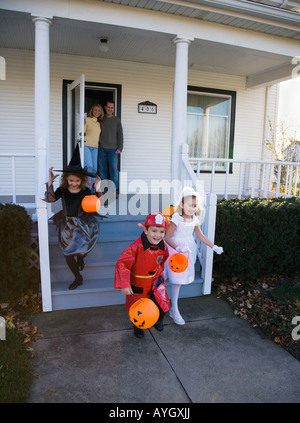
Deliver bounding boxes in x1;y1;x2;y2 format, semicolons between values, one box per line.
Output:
187;87;236;171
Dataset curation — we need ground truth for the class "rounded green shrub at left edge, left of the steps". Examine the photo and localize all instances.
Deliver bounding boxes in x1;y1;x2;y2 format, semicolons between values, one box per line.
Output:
0;204;31;300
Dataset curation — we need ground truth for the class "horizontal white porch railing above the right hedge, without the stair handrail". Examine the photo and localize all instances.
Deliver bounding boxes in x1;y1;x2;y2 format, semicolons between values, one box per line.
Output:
182;144;300;199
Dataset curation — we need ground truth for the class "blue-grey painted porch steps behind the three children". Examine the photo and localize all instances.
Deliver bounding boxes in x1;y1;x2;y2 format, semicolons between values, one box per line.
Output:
45;199;203;310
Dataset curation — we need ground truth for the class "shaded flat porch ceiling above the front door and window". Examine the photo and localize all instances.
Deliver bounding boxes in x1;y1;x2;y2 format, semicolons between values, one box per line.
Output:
0;10;300;85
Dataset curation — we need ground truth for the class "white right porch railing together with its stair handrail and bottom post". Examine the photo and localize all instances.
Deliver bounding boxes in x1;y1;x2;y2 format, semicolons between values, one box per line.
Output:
181;144;300;294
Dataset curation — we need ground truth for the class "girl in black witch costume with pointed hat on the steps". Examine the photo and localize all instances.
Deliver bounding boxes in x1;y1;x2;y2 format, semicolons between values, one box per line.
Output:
45;144;101;289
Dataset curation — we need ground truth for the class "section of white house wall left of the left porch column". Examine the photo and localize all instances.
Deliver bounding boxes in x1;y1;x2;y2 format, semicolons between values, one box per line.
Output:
0;50;35;195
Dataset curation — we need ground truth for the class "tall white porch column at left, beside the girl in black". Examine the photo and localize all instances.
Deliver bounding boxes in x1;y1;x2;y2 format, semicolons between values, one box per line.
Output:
33;17;52;311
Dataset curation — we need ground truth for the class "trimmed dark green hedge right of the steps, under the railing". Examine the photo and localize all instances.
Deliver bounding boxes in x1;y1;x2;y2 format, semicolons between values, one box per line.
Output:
214;197;300;278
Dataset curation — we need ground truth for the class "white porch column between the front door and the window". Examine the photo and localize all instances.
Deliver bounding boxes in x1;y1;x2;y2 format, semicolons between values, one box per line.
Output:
171;36;192;200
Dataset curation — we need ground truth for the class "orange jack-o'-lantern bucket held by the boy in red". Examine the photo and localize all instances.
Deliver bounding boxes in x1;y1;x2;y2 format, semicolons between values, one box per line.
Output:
129;298;159;329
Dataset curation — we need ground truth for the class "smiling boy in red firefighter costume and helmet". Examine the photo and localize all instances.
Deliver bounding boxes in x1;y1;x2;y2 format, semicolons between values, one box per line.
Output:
115;213;170;338
